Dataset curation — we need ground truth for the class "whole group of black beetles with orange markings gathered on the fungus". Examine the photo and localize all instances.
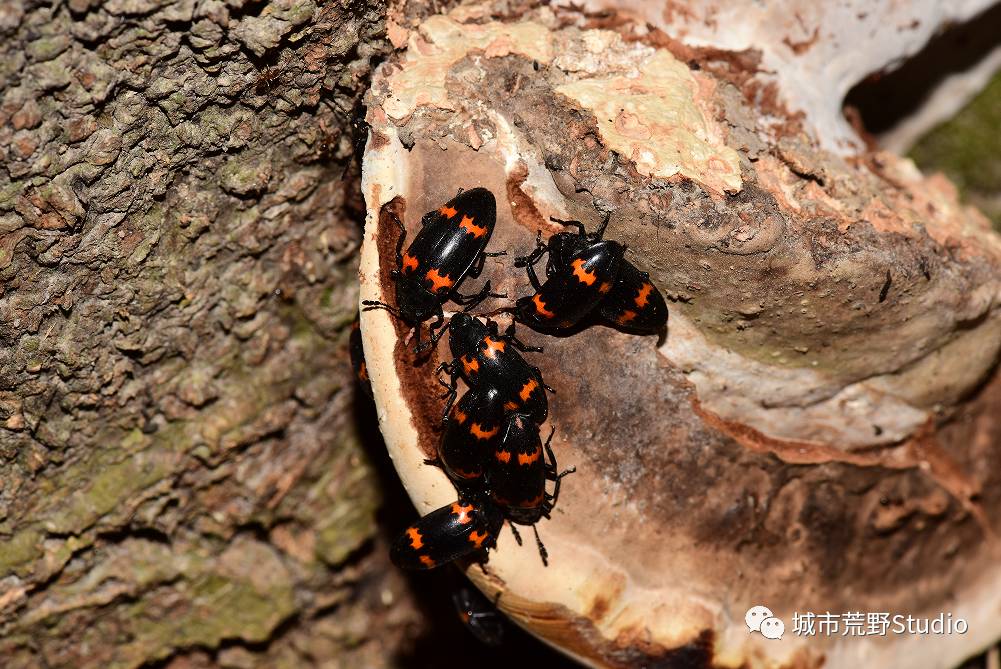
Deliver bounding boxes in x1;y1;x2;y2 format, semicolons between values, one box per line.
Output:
350;188;668;569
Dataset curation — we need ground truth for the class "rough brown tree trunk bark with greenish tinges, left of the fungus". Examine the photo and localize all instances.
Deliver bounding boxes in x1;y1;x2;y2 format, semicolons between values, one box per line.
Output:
0;0;997;668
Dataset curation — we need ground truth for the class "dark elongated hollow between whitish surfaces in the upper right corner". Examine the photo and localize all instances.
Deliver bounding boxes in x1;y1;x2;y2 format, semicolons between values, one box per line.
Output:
844;3;1001;134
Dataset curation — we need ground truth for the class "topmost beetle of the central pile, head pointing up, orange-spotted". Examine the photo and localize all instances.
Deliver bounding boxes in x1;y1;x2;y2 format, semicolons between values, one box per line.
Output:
437;313;555;423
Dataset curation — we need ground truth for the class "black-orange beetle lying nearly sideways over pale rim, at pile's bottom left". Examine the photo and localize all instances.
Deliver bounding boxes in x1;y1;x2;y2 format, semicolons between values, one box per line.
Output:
389;495;504;570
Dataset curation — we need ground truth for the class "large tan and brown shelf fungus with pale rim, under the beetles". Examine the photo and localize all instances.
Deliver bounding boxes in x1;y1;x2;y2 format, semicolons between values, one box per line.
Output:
360;8;1001;668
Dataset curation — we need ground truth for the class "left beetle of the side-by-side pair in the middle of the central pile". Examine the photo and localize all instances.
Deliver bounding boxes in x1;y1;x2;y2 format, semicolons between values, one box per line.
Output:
438;388;504;487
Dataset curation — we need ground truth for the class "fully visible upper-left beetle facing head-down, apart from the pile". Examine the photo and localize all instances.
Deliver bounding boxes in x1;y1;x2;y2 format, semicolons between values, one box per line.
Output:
362;187;507;353
